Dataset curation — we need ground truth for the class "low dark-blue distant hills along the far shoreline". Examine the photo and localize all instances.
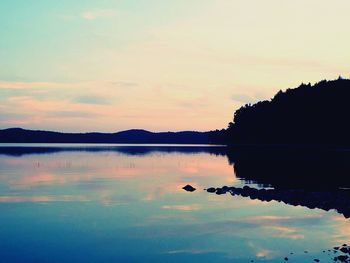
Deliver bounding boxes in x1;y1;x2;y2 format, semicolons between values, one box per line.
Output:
0;128;221;144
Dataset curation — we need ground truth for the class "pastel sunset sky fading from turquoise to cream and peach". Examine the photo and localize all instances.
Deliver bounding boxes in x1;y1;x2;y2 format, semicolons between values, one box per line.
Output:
0;0;350;132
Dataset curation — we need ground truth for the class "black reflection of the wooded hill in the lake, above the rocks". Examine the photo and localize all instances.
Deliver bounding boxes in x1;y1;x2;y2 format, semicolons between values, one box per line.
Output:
228;148;350;189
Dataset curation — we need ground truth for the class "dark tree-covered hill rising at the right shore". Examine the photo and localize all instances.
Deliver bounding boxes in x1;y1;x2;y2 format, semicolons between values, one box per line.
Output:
227;78;350;146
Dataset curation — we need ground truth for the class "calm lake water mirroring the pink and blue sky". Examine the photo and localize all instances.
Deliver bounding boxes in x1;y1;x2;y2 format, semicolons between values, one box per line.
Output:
0;145;350;262
